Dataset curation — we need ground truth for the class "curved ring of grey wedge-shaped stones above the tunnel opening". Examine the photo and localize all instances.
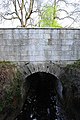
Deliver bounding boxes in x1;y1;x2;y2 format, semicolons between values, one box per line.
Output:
23;62;64;79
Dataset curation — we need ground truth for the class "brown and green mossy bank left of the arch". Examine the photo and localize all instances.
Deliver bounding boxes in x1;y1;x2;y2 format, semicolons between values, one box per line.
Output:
0;62;22;112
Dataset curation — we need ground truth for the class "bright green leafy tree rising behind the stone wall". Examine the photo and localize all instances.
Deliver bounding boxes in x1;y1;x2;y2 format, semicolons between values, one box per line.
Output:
39;5;62;28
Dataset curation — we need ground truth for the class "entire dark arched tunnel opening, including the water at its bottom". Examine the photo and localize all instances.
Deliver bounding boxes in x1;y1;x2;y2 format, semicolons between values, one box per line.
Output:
16;72;62;120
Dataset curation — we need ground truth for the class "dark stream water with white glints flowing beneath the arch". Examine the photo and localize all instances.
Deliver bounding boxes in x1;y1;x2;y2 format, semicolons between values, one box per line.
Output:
16;89;57;120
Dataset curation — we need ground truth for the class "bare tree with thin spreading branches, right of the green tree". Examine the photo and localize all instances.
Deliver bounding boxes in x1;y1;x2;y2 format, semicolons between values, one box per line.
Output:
55;0;80;27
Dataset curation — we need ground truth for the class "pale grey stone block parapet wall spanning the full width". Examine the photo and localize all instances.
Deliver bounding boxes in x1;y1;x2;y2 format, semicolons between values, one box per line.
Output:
0;28;80;62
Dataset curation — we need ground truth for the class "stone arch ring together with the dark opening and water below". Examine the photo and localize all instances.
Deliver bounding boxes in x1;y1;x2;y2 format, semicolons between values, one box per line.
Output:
19;63;63;120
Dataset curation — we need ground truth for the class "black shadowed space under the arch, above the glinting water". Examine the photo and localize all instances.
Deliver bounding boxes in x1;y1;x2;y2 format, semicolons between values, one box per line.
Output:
25;72;63;101
